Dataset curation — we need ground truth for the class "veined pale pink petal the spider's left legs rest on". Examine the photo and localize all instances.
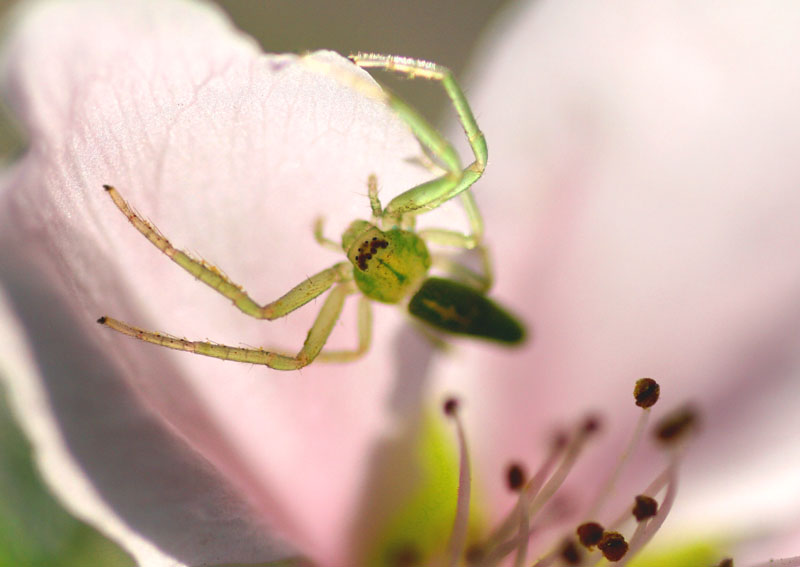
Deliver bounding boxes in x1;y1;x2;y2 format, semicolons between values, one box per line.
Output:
0;0;438;565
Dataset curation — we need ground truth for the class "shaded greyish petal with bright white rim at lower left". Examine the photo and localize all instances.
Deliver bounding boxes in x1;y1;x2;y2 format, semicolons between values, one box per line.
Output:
0;288;294;567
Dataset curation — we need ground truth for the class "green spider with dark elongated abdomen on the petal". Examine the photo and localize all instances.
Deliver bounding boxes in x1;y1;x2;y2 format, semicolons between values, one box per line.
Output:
97;53;525;370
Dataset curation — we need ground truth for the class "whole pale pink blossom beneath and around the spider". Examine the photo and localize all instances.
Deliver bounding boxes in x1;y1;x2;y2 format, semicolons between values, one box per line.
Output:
0;0;800;567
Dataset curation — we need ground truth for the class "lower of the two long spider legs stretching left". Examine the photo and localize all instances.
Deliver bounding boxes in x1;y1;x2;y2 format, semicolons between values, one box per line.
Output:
97;282;360;370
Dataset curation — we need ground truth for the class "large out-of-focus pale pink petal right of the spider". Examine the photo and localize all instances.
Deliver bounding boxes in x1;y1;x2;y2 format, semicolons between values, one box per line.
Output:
441;0;800;552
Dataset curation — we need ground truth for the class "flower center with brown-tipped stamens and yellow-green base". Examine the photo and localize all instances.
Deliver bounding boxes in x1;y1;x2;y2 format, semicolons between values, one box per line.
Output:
360;378;800;567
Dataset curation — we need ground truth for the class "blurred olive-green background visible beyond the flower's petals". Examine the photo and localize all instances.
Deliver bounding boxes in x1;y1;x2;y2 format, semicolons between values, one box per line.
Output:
0;0;511;567
